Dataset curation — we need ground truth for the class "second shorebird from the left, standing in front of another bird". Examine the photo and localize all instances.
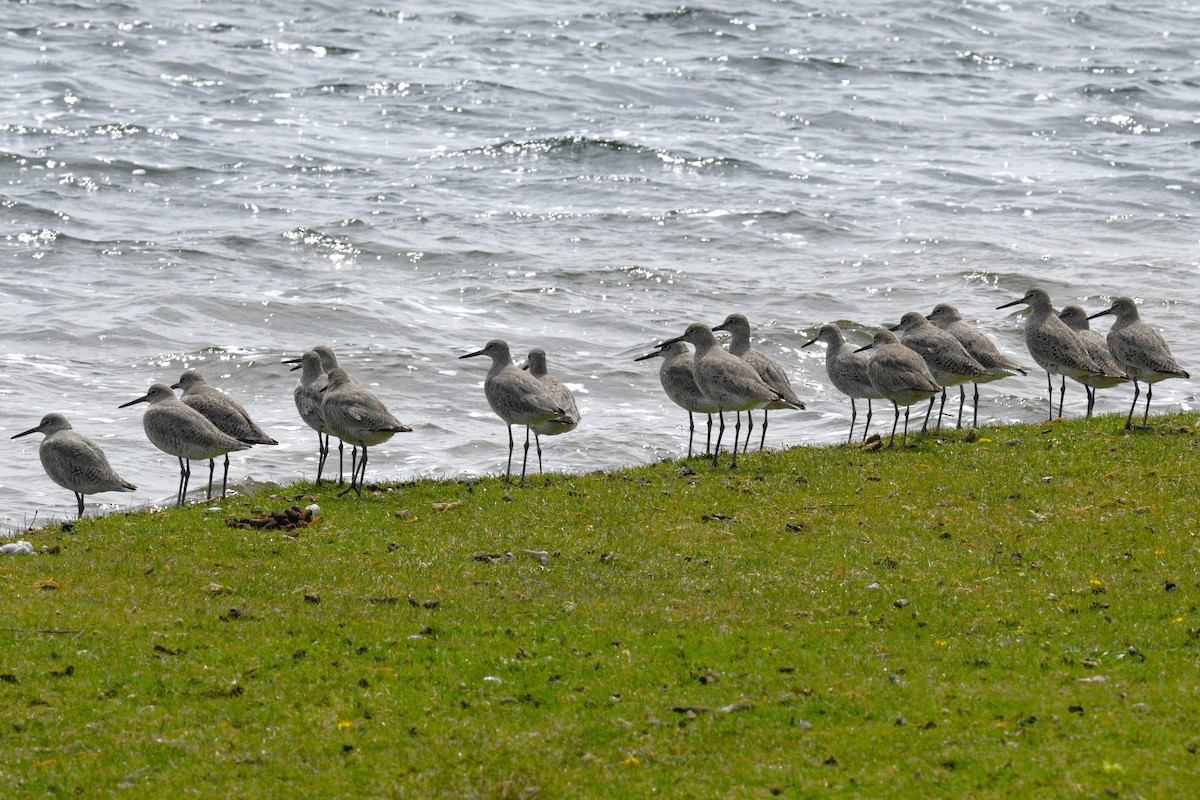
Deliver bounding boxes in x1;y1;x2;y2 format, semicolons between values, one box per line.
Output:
118;384;250;506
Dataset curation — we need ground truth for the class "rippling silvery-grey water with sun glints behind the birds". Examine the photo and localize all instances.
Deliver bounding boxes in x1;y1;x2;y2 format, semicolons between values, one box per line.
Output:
0;0;1200;527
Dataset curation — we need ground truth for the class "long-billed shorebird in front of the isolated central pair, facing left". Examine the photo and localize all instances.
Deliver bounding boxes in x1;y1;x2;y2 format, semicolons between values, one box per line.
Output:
458;339;578;483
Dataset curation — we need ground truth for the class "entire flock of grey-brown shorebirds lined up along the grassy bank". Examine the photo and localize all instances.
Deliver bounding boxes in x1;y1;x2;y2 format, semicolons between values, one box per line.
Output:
12;288;1189;517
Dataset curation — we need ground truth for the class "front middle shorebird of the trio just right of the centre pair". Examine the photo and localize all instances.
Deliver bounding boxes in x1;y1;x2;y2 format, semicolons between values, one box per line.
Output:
659;323;796;467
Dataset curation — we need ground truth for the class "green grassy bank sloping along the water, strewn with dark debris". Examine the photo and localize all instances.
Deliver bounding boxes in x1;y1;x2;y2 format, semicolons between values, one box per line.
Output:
0;416;1200;798
